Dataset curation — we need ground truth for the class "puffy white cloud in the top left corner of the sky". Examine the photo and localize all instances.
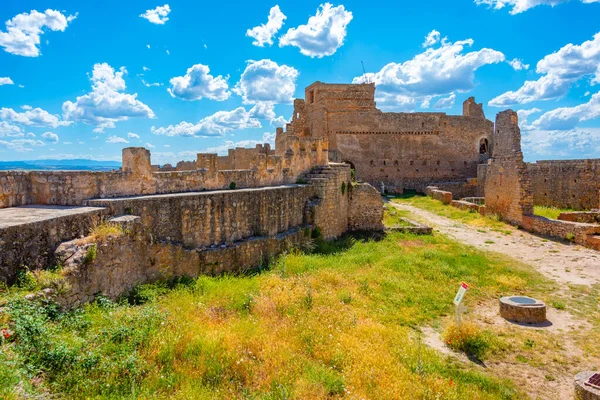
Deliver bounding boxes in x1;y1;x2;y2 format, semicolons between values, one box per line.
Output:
0;9;77;57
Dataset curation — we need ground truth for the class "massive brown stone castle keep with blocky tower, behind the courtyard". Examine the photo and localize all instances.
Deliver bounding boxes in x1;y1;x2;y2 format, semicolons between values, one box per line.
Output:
287;82;494;192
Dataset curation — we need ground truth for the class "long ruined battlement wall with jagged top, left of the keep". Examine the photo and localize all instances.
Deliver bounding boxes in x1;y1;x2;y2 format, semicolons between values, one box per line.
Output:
0;135;328;208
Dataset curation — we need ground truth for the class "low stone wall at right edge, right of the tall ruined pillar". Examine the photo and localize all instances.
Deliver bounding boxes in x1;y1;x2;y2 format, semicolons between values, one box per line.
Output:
523;215;600;246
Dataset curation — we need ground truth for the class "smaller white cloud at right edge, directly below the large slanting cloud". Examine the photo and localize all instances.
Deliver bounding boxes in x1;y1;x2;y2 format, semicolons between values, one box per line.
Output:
532;92;600;130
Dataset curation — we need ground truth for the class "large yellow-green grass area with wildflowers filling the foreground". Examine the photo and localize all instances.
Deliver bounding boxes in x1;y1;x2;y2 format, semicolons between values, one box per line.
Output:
0;208;598;399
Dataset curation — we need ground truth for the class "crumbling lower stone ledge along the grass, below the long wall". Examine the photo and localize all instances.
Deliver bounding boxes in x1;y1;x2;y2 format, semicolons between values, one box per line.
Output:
56;216;311;307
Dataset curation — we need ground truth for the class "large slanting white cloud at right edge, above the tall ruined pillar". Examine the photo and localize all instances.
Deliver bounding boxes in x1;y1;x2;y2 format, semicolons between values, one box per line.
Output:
489;32;600;107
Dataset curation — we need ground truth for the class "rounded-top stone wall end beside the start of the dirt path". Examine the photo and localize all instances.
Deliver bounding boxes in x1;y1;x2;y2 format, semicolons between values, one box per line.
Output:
348;183;383;231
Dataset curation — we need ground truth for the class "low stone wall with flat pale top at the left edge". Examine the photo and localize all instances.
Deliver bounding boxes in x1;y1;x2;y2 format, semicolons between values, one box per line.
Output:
0;207;106;284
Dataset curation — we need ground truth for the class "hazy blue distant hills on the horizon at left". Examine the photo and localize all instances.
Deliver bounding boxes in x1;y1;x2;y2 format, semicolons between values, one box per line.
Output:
0;159;121;171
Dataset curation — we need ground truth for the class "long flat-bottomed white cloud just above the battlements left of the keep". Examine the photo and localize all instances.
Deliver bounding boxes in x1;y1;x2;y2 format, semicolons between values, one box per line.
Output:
151;107;262;137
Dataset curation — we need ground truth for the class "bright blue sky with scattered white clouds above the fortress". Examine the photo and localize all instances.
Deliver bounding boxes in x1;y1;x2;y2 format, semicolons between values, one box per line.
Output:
0;0;600;163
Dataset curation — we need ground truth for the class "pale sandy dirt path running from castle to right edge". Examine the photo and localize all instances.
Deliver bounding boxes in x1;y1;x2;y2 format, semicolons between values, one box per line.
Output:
389;202;600;286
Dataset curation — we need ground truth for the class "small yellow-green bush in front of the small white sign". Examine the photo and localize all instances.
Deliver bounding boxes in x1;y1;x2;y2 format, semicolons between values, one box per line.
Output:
444;322;493;360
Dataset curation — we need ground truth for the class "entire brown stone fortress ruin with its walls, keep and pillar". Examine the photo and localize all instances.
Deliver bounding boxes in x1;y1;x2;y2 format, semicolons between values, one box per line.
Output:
0;82;600;304
